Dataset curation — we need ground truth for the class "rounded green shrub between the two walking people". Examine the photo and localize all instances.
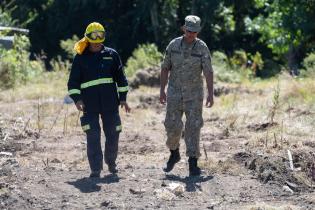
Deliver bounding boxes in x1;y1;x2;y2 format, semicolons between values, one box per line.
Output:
125;44;163;77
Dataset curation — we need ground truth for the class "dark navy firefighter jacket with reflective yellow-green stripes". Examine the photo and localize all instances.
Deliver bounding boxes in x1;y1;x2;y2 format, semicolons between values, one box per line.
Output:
68;46;128;113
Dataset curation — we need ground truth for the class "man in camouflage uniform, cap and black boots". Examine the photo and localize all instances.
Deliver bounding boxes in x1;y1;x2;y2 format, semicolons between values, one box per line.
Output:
160;15;213;176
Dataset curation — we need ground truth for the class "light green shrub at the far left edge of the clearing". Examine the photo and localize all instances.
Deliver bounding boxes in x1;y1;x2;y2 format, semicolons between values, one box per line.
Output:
0;35;44;89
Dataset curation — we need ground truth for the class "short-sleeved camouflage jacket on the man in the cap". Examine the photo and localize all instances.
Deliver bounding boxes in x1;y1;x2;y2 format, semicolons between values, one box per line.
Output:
161;36;213;101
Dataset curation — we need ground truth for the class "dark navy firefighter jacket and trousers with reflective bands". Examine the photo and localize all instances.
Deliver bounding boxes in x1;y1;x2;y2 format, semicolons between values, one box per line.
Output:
68;46;128;171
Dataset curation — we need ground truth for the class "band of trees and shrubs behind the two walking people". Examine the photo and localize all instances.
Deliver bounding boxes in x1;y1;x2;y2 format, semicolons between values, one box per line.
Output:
0;0;315;87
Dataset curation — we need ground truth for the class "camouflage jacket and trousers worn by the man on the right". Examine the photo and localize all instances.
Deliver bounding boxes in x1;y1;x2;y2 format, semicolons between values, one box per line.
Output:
161;37;212;158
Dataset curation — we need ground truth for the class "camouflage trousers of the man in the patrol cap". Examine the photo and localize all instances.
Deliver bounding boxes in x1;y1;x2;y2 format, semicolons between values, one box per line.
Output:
164;98;203;158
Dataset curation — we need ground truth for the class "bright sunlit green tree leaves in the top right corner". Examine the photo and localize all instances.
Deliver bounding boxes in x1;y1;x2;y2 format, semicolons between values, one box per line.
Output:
246;0;315;61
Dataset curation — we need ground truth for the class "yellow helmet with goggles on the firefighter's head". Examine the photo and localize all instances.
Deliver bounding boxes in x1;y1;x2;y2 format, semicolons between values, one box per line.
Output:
84;22;105;43
